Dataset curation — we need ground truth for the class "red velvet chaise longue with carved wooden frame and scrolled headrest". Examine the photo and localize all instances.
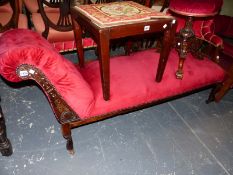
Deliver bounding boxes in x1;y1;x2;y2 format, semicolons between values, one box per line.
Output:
0;29;225;156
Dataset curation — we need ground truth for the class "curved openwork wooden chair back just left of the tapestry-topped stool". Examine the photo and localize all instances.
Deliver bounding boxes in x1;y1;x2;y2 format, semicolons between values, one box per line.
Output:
37;0;72;38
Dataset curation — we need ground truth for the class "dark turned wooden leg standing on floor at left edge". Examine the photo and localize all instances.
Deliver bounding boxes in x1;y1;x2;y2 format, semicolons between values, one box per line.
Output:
0;106;12;156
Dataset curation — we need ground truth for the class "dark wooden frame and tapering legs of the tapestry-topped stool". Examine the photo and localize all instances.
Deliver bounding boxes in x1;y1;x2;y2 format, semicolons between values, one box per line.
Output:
71;2;176;100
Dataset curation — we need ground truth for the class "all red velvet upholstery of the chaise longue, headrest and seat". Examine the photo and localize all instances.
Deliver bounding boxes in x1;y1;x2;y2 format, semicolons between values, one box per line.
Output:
0;30;225;119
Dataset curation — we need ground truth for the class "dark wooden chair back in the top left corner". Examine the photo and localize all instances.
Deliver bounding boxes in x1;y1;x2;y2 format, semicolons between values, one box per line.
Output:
0;0;19;33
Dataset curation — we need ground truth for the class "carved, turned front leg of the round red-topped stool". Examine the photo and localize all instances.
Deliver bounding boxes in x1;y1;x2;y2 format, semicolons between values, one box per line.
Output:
176;16;194;79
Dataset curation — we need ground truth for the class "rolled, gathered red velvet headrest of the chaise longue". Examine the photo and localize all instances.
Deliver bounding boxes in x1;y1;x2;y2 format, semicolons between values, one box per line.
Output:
0;29;94;117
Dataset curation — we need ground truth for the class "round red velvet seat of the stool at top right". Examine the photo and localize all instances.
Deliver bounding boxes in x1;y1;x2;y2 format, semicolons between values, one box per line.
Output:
169;0;223;17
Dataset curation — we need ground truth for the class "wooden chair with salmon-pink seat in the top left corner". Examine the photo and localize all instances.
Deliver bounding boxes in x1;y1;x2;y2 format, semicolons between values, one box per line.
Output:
0;0;28;33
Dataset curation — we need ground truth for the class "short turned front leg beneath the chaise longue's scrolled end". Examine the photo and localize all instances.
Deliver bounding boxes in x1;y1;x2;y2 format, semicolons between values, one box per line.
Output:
61;123;75;155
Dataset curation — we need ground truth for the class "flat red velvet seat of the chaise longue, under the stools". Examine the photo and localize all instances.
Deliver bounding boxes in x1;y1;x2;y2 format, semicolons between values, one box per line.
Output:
80;50;225;118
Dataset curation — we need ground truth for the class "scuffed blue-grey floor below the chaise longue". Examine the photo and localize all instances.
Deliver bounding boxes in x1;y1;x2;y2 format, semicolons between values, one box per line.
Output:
0;49;233;175
